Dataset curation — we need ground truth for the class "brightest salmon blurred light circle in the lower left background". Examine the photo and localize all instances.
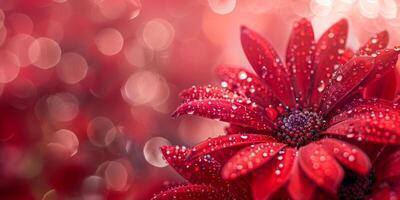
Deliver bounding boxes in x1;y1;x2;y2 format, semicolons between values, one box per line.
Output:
47;129;79;156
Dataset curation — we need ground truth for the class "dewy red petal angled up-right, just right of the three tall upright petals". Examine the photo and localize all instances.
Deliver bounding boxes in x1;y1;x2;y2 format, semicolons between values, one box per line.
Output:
320;57;373;114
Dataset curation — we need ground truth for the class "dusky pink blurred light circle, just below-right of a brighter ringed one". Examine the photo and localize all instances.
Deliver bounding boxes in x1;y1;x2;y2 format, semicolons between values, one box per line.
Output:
56;52;88;84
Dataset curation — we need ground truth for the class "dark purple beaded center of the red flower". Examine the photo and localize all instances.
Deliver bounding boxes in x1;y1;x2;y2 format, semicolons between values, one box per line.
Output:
276;110;324;147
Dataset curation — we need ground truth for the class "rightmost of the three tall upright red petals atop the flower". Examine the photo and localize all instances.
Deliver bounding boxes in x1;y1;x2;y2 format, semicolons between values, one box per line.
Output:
311;19;348;106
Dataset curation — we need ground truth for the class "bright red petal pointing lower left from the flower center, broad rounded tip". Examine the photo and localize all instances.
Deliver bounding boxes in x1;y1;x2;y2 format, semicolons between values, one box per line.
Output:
222;142;286;180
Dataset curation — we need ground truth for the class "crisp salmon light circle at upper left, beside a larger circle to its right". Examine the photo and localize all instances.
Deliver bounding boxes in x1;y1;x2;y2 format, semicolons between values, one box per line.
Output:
95;28;124;56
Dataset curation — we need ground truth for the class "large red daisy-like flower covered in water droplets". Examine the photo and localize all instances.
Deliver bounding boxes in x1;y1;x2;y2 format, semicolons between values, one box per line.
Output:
156;19;400;199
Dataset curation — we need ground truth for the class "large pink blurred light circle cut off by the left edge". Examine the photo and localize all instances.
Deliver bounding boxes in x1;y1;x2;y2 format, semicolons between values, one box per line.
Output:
0;50;20;83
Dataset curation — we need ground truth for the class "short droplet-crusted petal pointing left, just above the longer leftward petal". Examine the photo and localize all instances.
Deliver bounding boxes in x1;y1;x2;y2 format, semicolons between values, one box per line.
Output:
180;86;246;102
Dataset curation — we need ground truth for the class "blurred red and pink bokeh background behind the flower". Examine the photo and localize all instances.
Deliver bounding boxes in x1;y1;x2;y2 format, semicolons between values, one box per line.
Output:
0;0;400;200
